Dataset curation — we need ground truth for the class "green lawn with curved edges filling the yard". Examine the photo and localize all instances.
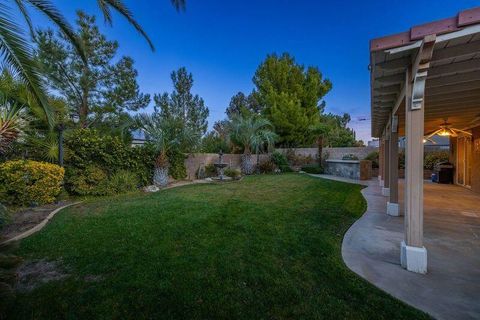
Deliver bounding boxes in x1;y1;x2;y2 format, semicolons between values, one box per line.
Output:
8;174;427;319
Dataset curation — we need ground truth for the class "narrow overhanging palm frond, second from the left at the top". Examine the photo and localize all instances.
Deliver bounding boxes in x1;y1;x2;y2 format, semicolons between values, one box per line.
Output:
23;0;87;61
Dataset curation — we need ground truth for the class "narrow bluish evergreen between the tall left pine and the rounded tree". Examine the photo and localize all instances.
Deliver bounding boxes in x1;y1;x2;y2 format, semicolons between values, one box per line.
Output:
153;67;209;152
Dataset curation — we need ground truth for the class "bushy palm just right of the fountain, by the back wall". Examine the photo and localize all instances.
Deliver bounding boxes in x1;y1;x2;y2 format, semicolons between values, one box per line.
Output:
228;115;277;174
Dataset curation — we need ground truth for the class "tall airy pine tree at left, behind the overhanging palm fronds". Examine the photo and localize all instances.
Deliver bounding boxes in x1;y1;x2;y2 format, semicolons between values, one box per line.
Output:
37;11;150;127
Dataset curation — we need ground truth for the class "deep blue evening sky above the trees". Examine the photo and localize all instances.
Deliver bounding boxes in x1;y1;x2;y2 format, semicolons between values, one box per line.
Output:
25;0;480;141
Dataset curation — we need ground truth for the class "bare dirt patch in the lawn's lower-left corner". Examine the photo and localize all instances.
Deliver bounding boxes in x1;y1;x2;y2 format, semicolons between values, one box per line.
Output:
15;259;69;292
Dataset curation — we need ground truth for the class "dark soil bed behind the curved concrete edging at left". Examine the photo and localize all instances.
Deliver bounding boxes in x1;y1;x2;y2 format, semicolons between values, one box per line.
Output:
0;201;69;242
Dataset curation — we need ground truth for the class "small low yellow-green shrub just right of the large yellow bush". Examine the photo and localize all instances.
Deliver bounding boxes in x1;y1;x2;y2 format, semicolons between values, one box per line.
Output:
65;165;109;196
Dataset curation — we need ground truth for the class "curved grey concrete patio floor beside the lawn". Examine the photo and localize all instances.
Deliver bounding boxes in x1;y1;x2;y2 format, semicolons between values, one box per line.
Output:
312;175;480;319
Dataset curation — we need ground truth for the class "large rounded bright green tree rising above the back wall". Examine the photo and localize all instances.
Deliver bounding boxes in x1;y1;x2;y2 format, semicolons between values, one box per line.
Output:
253;53;332;146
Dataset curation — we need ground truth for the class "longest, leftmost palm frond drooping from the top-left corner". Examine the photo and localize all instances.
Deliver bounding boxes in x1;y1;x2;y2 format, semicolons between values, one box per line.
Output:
0;3;53;125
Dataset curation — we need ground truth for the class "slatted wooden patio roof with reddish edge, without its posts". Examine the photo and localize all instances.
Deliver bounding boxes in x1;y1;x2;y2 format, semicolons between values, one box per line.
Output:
370;7;480;137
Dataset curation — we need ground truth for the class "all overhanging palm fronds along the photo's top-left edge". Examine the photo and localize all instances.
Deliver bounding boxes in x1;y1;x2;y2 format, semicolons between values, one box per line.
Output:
0;0;185;124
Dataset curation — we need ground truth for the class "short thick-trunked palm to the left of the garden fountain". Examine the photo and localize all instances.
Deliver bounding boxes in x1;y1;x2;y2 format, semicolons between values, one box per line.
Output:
134;113;196;187
